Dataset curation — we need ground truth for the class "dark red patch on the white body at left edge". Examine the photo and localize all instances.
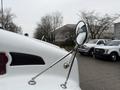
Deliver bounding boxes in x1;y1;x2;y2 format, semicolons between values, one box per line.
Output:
0;53;8;75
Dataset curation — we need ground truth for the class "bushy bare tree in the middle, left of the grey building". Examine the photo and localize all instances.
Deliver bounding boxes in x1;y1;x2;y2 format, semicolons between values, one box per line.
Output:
34;12;63;43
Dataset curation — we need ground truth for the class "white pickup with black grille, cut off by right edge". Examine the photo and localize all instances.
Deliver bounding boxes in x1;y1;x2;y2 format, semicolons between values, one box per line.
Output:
94;40;120;61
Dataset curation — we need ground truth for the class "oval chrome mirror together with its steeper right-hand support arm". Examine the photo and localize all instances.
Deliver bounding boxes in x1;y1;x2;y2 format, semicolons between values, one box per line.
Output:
60;21;88;89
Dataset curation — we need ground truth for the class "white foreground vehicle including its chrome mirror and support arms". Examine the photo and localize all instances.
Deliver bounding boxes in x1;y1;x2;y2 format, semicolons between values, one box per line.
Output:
0;21;87;90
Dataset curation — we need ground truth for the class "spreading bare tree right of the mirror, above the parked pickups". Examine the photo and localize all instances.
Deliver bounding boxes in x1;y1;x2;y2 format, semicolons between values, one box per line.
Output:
80;11;120;39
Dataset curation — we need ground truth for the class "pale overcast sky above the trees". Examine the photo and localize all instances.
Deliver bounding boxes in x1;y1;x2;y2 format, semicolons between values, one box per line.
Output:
3;0;120;36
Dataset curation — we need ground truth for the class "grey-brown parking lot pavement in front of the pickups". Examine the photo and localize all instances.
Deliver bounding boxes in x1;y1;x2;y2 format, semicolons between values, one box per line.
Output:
77;54;120;90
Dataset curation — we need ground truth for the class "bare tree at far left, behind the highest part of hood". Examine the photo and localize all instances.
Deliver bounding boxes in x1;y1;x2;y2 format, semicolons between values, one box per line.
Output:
0;9;22;33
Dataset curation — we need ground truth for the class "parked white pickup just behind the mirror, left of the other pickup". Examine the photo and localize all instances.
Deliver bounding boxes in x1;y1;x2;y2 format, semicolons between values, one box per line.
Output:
79;39;108;56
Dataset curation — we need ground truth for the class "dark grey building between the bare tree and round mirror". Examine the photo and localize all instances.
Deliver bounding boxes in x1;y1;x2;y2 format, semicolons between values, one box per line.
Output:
55;24;76;46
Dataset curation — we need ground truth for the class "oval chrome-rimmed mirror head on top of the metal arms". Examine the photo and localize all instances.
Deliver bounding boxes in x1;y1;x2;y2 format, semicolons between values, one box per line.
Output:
76;21;88;45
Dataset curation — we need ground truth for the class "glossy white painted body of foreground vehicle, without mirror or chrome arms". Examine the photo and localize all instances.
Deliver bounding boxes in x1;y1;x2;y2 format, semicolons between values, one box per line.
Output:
0;30;81;90
